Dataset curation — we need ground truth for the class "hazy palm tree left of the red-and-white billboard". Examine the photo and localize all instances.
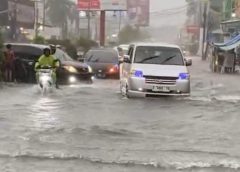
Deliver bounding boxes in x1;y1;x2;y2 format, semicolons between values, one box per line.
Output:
46;0;76;39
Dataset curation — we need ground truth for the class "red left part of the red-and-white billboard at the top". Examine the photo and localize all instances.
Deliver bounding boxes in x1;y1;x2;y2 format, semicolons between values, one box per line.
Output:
77;0;101;11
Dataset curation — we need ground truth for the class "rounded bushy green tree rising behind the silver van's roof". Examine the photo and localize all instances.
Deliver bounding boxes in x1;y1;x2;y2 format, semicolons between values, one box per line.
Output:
118;25;150;44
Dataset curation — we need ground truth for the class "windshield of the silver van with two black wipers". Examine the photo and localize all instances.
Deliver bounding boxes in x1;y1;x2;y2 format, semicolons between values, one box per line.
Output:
134;46;184;65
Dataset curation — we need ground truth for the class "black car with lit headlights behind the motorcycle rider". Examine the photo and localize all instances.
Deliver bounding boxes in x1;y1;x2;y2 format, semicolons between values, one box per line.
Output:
4;43;93;84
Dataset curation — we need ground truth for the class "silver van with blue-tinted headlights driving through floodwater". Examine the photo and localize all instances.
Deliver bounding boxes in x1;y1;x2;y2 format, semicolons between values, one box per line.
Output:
120;43;191;97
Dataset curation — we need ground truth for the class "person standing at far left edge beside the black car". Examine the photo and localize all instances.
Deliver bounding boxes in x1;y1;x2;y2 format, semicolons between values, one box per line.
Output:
4;44;15;82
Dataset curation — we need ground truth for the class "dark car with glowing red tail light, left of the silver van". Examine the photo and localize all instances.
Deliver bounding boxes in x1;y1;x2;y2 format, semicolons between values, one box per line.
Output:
84;48;119;78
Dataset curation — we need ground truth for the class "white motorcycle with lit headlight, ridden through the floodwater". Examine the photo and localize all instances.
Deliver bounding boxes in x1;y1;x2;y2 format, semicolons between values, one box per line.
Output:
38;67;54;95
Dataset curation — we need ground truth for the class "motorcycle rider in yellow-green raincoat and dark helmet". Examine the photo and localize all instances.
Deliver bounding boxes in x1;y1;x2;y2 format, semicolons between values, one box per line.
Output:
35;48;59;87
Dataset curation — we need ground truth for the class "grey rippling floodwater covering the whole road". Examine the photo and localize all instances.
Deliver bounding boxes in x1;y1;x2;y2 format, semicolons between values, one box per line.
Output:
0;57;240;172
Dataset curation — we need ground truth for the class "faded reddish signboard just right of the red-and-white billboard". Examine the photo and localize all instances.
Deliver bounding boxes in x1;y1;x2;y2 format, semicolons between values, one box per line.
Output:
127;0;150;26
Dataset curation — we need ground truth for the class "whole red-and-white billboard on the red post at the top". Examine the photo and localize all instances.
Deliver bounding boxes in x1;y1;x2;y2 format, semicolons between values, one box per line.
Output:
77;0;127;11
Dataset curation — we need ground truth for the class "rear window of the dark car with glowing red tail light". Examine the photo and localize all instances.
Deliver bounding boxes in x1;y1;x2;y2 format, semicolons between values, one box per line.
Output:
86;50;118;63
